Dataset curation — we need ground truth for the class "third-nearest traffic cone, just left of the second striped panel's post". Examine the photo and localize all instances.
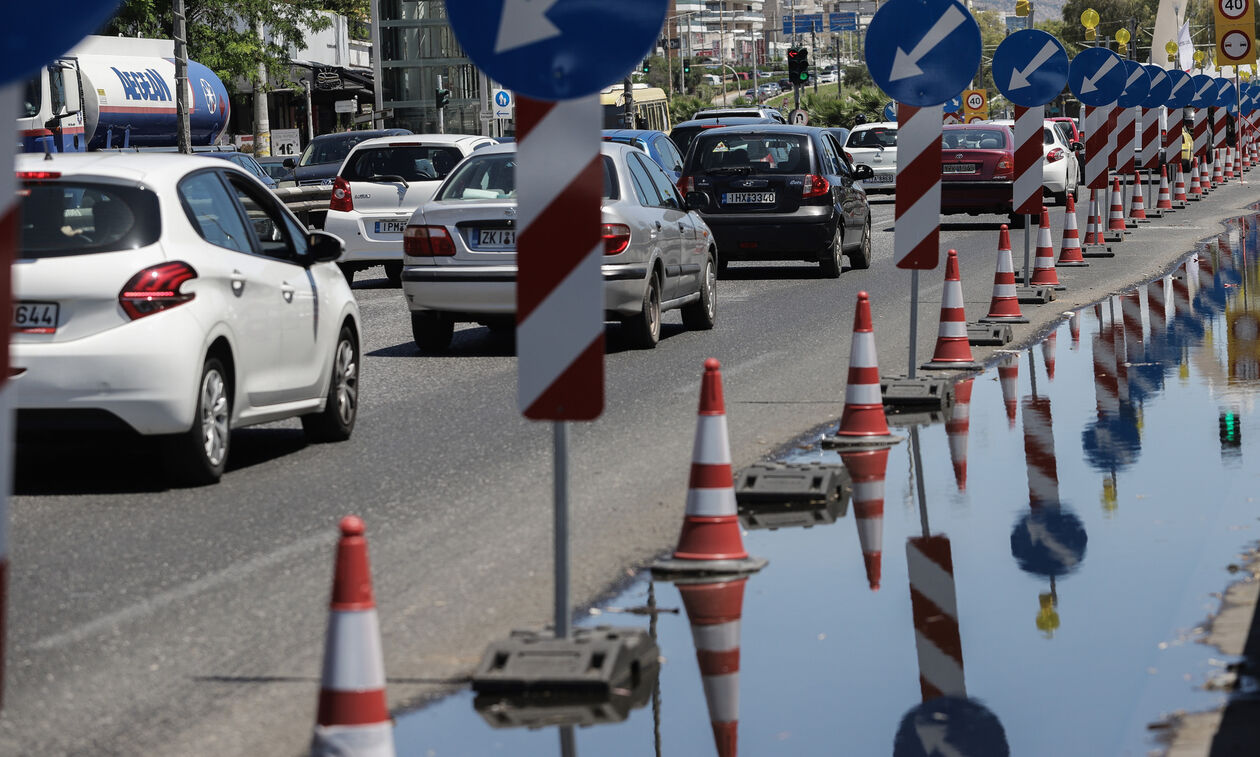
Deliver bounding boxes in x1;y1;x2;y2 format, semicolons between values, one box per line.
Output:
827;292;901;446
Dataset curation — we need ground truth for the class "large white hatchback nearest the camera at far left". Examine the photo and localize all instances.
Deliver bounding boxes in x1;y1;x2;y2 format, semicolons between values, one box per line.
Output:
10;152;360;485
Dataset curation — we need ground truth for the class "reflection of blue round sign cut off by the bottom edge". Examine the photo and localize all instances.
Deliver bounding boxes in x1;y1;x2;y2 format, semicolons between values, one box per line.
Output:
892;697;1011;757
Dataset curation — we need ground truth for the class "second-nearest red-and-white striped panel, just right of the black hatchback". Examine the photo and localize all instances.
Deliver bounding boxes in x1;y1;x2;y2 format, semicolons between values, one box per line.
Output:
892;103;944;270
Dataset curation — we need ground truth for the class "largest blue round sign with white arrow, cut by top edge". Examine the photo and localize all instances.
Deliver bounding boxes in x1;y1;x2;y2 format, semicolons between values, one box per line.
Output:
446;0;669;101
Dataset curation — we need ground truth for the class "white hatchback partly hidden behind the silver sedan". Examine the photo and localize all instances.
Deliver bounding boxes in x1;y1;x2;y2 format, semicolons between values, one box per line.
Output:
324;134;496;285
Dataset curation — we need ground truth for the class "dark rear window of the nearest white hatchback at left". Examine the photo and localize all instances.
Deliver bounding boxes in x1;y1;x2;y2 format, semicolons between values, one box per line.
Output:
18;181;161;258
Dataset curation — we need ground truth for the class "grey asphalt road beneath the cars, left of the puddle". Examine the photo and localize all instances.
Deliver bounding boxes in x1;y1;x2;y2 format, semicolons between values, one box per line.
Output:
0;184;1255;754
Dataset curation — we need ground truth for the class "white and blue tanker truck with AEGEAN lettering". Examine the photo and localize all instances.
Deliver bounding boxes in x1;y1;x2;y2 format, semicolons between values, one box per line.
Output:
18;37;229;152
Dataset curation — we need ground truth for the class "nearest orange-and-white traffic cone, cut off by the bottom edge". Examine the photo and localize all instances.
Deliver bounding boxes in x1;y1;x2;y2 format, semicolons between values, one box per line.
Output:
311;515;394;757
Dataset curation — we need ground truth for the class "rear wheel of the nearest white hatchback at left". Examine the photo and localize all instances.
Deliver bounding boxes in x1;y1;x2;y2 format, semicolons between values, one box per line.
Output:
163;358;232;486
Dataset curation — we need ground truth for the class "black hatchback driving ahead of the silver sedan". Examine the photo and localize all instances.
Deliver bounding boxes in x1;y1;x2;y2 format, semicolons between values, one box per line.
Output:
678;123;872;277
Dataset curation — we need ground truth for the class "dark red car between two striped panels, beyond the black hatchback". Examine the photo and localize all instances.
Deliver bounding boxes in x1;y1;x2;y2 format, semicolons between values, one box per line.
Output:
941;123;1023;228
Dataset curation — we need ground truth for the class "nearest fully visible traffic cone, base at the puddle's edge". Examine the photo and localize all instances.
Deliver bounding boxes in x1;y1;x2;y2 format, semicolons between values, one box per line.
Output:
651;358;766;574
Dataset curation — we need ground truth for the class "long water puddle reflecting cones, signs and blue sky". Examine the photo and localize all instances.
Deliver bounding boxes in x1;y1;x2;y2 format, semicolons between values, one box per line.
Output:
396;219;1260;757
